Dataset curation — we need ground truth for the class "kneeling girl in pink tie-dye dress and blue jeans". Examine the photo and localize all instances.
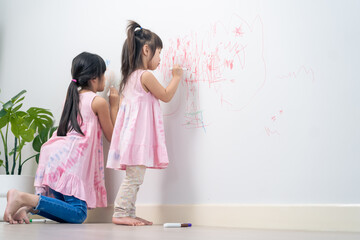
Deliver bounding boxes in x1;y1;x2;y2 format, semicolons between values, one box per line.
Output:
4;52;119;223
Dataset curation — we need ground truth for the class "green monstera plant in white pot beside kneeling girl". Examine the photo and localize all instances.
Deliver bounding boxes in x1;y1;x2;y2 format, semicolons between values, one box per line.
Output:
0;90;55;220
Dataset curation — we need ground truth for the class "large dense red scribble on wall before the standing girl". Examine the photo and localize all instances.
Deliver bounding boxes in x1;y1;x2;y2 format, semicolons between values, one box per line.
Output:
158;15;266;130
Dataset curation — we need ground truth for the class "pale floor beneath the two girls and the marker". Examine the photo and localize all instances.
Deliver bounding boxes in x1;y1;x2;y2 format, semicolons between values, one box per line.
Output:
0;222;360;240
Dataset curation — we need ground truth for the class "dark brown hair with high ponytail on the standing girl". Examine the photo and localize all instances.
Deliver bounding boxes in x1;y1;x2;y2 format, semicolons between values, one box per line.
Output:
120;21;163;92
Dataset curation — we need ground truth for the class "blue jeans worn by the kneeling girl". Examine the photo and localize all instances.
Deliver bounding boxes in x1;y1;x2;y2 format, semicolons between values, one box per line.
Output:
34;189;87;223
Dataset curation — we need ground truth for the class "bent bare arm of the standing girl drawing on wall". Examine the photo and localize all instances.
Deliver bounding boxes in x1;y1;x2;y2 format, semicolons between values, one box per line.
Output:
141;65;183;102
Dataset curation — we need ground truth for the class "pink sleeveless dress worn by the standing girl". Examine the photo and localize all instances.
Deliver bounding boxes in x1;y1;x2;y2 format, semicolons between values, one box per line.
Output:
106;70;169;170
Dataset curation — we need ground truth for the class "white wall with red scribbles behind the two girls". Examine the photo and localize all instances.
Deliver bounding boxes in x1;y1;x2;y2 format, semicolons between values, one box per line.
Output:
0;0;360;204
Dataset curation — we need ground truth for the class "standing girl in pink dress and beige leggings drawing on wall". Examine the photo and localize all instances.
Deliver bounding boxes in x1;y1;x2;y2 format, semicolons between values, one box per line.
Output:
107;21;183;226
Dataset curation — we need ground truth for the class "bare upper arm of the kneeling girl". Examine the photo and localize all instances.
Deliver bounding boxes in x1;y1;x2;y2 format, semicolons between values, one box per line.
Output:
91;96;114;142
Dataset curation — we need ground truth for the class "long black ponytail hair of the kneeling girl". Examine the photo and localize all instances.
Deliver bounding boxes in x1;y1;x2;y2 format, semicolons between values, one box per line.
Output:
57;52;106;136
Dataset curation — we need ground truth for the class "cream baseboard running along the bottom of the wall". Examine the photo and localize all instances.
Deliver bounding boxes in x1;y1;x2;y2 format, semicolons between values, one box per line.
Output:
86;204;360;232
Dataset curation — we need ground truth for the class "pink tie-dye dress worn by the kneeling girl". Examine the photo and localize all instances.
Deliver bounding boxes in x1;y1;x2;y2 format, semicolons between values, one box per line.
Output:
34;92;107;208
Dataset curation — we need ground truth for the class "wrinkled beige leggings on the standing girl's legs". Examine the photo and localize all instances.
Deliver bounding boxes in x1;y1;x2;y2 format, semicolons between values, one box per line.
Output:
113;166;146;218
